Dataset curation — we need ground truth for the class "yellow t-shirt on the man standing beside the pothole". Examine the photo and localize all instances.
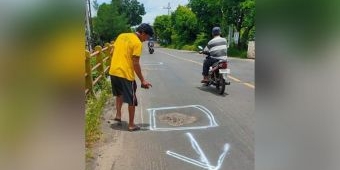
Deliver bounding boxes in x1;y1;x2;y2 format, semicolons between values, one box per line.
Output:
109;33;142;81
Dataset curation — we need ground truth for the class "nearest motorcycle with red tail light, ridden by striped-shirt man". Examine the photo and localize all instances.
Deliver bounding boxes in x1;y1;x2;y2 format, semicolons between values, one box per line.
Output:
198;46;230;94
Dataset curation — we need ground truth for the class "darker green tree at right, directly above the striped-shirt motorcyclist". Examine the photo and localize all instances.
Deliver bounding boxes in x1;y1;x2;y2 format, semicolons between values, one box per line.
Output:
188;0;255;49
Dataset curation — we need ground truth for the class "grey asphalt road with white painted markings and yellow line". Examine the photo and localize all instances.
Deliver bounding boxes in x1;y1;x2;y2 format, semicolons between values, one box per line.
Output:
94;43;255;170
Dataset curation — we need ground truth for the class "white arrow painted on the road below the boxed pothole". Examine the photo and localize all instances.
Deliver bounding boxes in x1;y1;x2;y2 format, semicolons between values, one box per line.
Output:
166;133;230;170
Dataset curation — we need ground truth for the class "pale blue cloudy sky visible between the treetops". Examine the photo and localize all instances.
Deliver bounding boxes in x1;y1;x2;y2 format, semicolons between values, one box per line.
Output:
91;0;189;24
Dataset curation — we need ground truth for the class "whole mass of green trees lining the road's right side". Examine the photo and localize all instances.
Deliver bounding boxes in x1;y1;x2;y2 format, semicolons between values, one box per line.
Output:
154;0;255;52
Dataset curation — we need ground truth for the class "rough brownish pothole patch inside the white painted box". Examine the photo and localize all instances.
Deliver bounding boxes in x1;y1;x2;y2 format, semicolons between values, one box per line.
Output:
158;112;197;126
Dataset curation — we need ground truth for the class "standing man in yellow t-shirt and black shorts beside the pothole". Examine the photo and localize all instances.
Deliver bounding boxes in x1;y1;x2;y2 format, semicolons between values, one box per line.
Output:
109;23;154;131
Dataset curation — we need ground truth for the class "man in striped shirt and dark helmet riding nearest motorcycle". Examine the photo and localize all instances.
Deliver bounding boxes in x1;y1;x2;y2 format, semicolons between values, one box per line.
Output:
201;27;227;83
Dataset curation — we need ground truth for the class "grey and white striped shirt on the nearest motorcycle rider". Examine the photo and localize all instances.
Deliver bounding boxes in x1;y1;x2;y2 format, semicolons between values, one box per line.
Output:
204;36;227;60
